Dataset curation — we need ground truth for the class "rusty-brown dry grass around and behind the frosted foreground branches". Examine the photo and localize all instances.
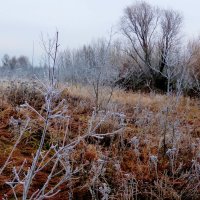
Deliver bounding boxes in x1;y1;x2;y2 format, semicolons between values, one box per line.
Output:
0;80;200;200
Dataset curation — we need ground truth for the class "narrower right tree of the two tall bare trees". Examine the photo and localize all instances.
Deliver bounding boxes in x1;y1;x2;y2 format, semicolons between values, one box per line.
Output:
158;10;182;93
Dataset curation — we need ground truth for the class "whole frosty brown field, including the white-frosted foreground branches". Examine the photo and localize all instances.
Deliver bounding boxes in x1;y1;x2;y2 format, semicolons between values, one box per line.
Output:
0;81;200;200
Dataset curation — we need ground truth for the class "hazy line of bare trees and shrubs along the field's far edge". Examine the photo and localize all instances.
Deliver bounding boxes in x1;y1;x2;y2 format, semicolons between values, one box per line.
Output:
1;1;200;95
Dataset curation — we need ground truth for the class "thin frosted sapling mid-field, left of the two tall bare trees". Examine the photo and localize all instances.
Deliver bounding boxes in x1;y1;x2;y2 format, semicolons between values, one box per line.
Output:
86;38;114;110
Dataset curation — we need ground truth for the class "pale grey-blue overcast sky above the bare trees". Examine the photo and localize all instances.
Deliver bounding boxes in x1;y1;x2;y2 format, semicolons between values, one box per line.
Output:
0;0;200;63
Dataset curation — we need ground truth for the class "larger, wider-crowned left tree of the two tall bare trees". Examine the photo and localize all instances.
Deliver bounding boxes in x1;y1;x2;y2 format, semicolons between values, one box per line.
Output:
121;2;159;76
